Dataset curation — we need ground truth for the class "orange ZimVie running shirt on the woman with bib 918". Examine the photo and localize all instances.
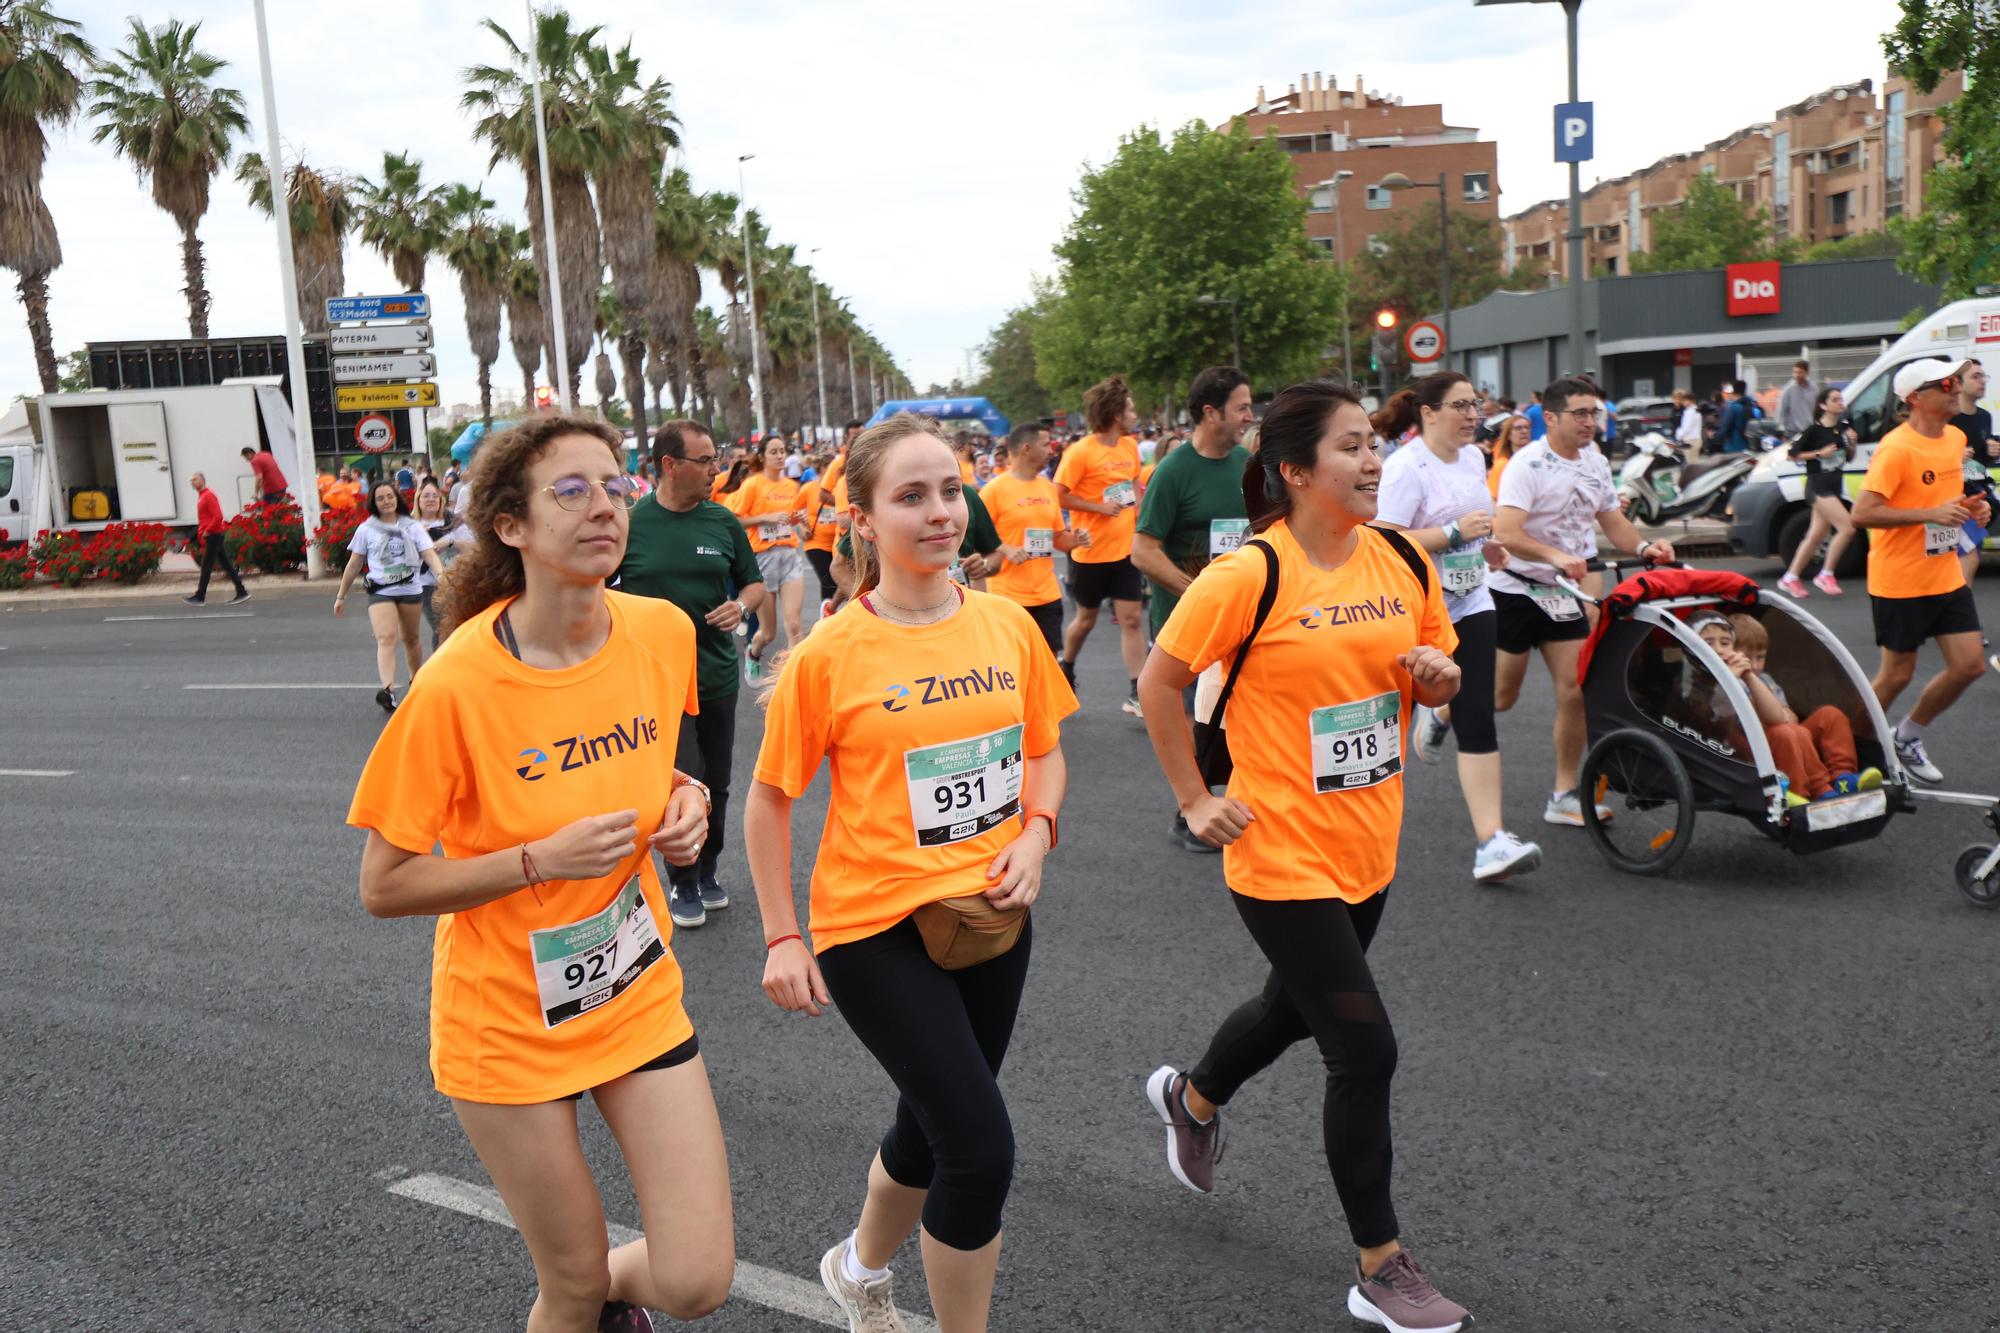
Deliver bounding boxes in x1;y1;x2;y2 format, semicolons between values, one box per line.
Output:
1160;520;1458;903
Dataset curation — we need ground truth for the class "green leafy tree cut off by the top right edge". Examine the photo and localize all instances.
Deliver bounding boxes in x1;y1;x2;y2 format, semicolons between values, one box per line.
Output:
1882;0;2000;300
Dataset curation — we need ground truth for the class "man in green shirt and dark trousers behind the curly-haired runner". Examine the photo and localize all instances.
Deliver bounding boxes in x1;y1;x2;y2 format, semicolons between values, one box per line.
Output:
618;420;770;929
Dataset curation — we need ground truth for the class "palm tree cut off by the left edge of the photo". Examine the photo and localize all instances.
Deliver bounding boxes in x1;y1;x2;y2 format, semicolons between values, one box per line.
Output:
0;0;96;394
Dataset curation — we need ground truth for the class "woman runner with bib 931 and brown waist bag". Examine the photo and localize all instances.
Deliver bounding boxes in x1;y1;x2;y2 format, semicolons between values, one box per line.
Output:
744;414;1076;1333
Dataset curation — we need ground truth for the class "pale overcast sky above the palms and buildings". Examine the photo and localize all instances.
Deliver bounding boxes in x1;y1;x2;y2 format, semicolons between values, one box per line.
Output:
0;0;1896;402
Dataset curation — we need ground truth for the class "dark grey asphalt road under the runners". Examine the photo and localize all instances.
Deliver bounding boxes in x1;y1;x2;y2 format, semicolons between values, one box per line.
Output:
0;566;2000;1331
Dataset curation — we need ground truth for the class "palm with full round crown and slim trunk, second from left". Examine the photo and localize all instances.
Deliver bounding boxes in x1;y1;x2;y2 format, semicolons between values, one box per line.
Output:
90;18;250;338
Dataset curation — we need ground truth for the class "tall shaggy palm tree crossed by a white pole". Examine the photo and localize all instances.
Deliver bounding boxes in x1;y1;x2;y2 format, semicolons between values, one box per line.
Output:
458;10;604;402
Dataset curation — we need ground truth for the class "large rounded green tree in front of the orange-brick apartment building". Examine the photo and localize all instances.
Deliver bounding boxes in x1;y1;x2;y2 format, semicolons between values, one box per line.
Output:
1032;120;1342;402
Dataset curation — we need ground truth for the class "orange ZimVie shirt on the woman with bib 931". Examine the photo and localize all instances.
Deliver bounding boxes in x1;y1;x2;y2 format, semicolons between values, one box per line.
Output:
756;590;1076;953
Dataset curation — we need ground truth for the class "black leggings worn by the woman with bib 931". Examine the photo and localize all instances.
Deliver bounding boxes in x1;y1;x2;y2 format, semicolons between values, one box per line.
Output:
820;913;1034;1249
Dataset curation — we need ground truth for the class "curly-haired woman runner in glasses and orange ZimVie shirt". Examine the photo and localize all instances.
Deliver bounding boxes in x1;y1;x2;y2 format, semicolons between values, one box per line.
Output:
348;416;736;1333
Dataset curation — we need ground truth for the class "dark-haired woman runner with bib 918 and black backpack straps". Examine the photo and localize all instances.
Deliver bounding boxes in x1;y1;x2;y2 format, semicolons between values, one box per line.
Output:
1138;380;1466;1331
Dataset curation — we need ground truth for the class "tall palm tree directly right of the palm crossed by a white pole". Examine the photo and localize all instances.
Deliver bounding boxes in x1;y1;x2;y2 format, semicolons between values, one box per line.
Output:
584;33;680;452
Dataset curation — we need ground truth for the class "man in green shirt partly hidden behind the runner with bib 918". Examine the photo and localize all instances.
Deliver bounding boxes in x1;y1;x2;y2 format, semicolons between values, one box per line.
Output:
1132;366;1256;853
